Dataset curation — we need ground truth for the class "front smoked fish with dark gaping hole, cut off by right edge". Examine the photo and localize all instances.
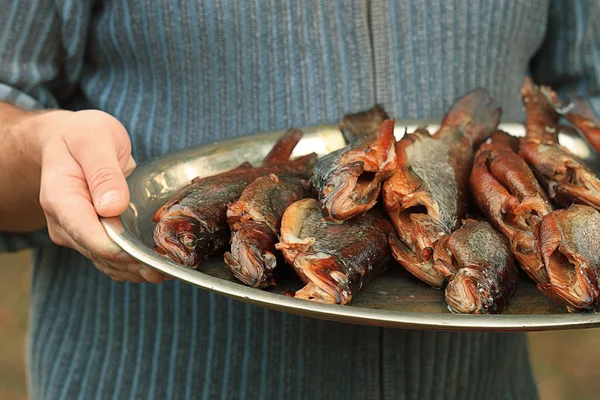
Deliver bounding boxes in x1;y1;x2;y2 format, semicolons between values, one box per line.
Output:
538;204;600;312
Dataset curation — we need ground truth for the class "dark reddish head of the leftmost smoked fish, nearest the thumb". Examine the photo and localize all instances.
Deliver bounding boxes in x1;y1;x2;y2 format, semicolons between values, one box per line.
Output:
154;215;213;268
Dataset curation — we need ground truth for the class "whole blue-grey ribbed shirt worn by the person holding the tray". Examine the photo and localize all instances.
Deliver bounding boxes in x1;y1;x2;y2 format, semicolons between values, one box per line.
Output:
0;0;600;399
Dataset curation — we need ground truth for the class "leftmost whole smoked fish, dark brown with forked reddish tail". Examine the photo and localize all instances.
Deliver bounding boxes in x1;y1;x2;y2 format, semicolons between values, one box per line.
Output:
153;129;317;268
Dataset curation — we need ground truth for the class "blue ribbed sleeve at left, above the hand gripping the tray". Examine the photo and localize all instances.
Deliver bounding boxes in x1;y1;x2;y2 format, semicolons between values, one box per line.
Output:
0;0;93;252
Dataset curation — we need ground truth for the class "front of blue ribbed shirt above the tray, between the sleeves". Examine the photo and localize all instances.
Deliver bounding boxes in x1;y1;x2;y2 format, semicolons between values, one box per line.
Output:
74;0;549;162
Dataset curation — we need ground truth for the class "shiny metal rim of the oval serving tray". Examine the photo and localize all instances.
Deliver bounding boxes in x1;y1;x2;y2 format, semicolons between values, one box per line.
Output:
100;119;600;331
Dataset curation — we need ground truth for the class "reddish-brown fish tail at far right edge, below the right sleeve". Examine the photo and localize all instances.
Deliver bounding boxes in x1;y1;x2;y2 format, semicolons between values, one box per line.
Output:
540;86;600;154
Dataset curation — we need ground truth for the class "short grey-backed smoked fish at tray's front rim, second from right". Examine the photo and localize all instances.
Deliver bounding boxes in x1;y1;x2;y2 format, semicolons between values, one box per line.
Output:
434;220;518;314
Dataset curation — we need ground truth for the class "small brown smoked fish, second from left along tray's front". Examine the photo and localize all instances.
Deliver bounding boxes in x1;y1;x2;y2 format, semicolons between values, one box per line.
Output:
224;174;311;289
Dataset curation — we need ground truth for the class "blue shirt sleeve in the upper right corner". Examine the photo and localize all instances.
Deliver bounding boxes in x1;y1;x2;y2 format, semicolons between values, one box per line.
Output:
531;0;600;112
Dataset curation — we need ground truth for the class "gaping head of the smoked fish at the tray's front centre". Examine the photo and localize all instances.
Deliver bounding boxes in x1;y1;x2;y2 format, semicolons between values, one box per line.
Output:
294;252;352;305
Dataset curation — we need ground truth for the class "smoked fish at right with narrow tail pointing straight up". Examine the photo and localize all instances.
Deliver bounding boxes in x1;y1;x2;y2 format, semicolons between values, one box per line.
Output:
519;78;600;209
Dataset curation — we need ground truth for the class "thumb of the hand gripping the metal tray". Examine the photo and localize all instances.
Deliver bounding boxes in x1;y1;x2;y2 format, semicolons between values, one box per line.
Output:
67;112;135;217
